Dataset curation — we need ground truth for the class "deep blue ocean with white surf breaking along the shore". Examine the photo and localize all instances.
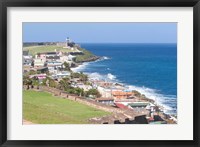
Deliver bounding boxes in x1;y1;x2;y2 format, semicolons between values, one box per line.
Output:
73;43;177;115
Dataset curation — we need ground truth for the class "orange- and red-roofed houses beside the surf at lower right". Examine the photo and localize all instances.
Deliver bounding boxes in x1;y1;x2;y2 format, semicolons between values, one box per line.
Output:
88;80;171;123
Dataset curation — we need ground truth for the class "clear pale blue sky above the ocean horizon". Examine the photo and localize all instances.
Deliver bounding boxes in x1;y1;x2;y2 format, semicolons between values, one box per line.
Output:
23;22;177;43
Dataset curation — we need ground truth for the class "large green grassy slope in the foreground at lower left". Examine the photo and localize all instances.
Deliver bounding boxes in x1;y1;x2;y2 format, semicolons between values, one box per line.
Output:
23;90;110;124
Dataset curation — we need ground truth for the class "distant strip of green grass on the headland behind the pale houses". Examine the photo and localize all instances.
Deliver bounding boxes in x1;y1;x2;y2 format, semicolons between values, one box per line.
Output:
23;45;71;56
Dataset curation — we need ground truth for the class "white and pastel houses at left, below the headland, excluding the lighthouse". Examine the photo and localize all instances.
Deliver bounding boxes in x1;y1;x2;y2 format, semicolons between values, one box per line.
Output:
23;50;76;78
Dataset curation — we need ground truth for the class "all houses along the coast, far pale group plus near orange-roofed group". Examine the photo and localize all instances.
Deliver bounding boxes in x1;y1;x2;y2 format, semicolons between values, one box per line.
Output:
23;40;174;124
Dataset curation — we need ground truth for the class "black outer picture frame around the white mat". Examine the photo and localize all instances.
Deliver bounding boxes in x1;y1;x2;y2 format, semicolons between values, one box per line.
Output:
0;0;200;147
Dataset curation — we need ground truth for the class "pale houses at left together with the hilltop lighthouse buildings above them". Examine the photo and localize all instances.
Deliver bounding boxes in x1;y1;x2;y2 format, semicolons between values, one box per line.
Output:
23;38;83;79
